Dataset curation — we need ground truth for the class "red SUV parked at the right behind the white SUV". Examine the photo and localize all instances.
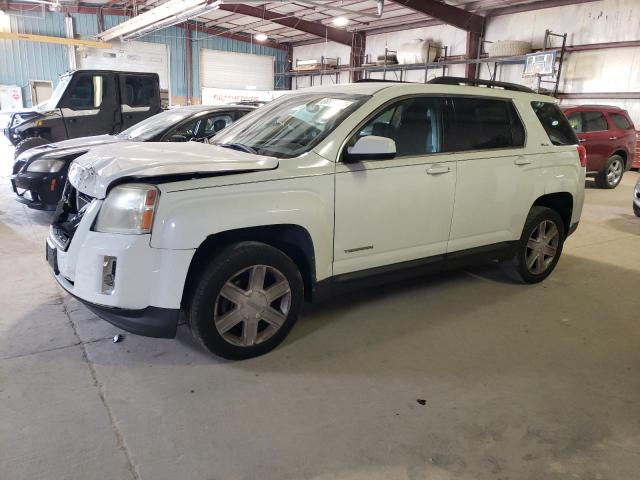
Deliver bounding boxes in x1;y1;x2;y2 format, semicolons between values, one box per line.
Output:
563;105;637;188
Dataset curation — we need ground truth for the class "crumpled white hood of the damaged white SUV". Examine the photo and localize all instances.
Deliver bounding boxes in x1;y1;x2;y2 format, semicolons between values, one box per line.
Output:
69;142;278;198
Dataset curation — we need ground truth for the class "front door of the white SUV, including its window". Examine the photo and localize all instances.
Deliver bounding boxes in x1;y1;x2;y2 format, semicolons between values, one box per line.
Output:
333;97;456;275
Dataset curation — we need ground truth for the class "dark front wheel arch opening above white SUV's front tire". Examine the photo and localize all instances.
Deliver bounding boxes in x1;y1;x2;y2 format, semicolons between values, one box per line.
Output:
182;224;316;305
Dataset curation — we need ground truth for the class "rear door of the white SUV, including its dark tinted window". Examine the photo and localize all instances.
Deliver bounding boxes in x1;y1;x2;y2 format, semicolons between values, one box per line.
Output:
444;97;538;261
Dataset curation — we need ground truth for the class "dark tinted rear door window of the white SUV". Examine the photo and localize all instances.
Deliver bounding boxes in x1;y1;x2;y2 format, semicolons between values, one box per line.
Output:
444;97;525;152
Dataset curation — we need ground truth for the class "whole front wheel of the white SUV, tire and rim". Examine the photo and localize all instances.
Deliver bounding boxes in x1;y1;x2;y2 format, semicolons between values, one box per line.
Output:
187;242;304;360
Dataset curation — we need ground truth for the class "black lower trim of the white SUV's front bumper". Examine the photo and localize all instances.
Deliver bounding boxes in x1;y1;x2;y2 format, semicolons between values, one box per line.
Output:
81;295;180;338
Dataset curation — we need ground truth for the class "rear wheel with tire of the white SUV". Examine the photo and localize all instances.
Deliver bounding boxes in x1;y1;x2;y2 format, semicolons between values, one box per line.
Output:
504;207;565;283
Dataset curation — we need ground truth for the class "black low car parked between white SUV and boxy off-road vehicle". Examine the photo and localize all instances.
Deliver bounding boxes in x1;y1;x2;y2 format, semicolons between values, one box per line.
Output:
11;105;254;210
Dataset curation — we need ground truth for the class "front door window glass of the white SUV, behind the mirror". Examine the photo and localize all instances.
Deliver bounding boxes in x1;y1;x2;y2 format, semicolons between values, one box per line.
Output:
347;97;441;157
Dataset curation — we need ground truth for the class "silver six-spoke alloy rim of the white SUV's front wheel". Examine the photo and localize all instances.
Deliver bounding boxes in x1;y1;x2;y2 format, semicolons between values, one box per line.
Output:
213;265;291;347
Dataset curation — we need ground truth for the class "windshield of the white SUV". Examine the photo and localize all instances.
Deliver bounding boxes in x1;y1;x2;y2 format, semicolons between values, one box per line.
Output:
212;92;370;158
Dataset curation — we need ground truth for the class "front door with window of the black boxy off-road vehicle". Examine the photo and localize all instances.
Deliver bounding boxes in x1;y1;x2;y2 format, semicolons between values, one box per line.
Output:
58;71;120;138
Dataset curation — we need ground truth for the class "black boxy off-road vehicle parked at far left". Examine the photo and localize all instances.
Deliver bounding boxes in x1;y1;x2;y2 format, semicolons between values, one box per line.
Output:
3;70;162;157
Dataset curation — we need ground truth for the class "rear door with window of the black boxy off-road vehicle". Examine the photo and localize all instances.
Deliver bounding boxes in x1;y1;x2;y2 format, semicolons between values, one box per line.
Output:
118;73;161;130
